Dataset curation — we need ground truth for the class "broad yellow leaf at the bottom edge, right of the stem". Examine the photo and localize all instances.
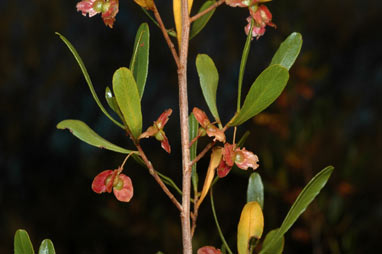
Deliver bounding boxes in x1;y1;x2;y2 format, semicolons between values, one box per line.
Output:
237;201;264;254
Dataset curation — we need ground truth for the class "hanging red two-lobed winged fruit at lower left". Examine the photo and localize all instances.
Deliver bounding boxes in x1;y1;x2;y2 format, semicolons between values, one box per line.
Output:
92;168;134;202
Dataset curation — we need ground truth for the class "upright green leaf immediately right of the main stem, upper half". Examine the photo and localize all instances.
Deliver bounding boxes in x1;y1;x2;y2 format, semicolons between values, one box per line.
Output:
196;54;220;123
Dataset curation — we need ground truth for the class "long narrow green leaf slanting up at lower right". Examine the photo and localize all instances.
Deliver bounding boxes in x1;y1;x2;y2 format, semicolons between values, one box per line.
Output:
259;166;334;254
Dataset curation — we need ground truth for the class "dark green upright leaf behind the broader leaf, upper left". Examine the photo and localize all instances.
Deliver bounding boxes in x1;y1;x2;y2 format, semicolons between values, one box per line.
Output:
130;23;150;98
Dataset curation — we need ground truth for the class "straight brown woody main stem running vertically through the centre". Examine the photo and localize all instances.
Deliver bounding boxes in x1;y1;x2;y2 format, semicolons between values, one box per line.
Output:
178;0;192;254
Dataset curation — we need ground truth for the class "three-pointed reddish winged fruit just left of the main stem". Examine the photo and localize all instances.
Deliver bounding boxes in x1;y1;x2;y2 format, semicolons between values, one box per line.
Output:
139;109;172;153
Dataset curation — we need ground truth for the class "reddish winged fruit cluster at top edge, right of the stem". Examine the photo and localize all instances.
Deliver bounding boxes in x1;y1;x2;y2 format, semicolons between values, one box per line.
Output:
225;0;276;39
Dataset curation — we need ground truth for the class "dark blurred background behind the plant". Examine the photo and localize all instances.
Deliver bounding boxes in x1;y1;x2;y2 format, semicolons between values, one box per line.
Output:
0;0;382;254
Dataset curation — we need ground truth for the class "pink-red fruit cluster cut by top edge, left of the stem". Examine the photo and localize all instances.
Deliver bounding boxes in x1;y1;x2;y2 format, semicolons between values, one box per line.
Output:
76;0;119;28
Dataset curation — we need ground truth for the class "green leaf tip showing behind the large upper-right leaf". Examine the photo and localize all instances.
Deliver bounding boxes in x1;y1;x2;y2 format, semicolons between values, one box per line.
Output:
270;32;302;70
